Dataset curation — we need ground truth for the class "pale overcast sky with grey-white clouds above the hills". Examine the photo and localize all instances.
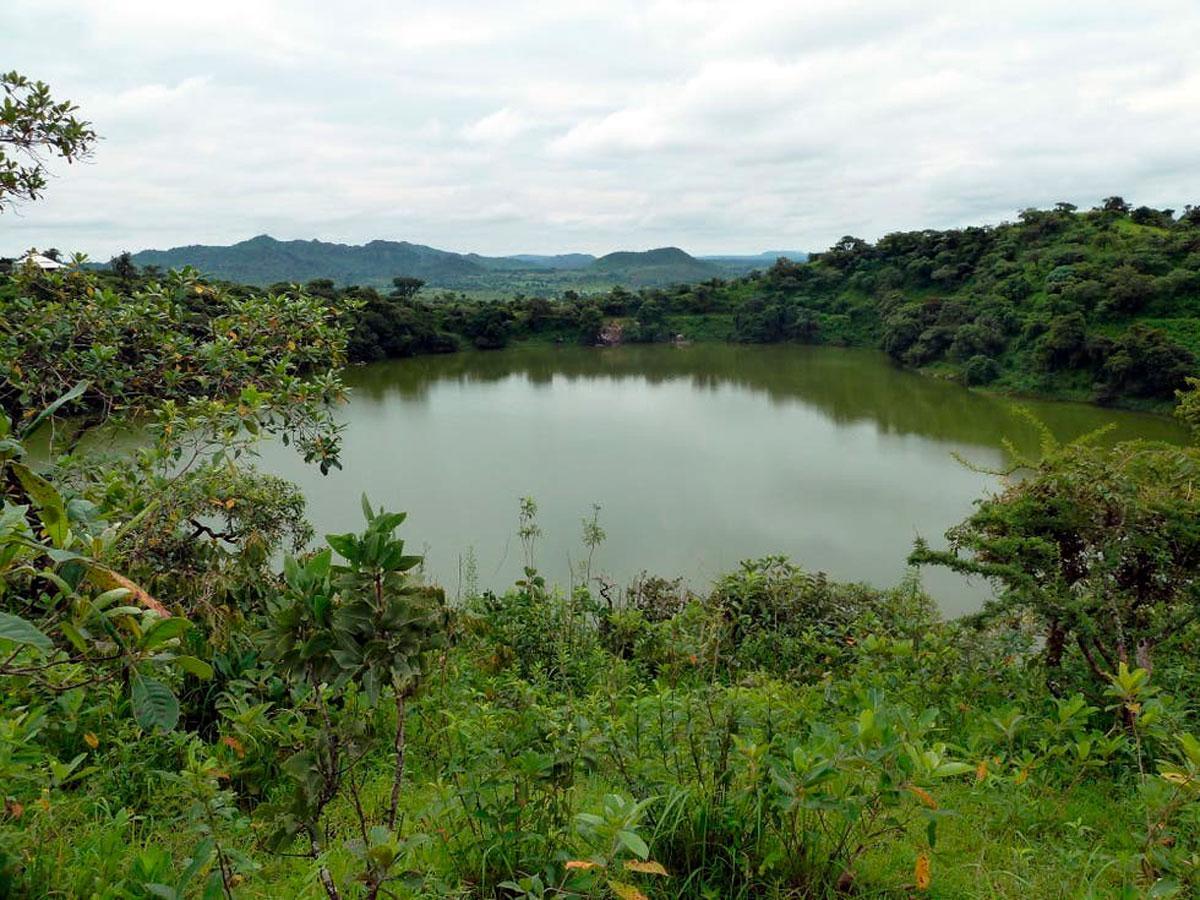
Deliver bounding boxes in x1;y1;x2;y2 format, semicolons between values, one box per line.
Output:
0;0;1200;259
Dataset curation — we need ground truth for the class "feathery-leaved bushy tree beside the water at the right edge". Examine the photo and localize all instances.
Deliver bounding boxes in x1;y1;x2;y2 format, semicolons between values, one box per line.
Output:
910;426;1200;689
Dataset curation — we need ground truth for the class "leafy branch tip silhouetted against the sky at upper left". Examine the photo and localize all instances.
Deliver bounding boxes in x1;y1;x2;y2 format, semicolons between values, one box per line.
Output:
0;72;96;212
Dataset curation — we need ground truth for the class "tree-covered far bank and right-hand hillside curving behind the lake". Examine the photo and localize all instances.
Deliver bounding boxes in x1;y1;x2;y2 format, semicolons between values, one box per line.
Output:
208;198;1200;408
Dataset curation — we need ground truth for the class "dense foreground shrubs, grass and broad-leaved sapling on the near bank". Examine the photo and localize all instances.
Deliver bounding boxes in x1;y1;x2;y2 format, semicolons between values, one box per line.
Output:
0;460;1200;898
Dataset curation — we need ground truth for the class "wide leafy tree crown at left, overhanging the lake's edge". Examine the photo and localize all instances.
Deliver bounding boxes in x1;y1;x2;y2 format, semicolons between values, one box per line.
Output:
0;269;346;469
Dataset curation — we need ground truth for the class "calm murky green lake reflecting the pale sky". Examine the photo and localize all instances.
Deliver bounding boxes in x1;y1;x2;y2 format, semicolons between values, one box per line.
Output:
255;344;1186;616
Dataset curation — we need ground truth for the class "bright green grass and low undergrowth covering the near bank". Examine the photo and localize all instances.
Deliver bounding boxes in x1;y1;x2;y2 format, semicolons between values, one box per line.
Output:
5;549;1200;898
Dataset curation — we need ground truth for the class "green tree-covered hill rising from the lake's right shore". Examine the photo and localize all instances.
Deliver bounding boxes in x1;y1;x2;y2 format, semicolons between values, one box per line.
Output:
720;197;1200;404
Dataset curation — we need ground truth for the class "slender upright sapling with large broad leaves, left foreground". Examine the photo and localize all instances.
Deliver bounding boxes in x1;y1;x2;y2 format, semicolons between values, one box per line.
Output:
270;497;446;900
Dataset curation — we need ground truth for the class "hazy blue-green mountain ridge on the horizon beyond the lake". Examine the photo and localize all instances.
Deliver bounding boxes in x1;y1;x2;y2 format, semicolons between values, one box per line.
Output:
133;234;806;290
